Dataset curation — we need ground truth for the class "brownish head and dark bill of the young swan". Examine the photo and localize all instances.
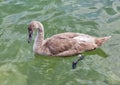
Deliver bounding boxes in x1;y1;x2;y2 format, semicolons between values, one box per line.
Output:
28;21;43;43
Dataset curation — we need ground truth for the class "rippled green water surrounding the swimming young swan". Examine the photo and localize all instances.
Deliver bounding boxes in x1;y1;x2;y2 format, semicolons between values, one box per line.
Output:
0;0;120;85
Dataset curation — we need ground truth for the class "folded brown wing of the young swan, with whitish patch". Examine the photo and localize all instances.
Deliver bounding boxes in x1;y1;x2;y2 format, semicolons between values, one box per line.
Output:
44;33;95;56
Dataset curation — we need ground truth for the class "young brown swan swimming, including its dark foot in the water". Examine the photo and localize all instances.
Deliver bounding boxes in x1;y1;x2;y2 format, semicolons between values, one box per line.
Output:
28;21;111;68
